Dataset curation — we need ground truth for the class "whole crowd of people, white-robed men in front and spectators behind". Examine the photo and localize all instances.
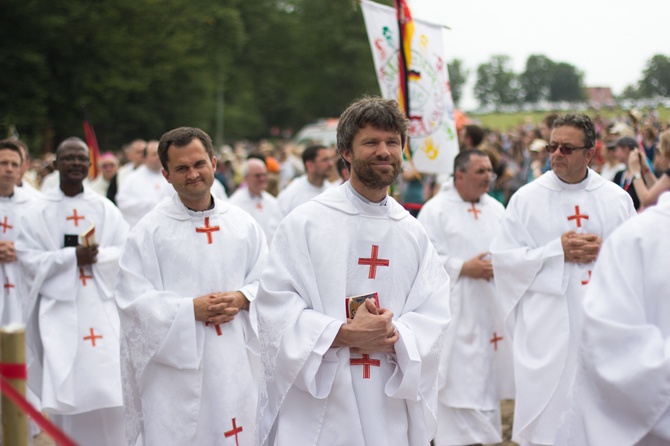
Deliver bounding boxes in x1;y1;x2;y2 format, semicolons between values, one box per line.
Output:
0;101;670;446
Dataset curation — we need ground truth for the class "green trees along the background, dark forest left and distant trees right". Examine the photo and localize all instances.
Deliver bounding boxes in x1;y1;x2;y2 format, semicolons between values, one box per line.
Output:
0;0;670;151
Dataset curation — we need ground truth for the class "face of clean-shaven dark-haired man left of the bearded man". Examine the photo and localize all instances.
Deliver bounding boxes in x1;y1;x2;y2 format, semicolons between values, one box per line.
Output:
162;138;216;211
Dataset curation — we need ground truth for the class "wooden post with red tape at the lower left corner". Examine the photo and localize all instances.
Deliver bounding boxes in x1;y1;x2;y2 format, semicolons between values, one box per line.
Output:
0;324;28;446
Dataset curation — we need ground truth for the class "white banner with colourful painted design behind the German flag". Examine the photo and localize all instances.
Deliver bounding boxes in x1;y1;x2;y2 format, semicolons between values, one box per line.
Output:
361;0;458;174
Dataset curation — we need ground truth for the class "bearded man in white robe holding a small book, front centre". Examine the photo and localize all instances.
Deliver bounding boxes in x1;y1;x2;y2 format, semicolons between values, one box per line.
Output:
252;98;450;446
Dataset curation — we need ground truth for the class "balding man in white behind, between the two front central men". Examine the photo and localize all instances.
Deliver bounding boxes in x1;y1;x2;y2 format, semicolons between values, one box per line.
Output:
230;158;278;244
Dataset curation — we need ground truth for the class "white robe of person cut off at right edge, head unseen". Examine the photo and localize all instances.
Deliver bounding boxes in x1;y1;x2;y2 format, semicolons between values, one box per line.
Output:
556;192;670;446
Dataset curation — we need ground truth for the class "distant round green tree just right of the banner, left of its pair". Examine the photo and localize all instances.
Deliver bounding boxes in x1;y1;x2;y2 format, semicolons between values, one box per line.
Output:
475;55;519;108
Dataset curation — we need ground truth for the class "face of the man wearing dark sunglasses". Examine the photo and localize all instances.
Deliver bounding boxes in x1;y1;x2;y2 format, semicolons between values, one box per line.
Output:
549;125;596;184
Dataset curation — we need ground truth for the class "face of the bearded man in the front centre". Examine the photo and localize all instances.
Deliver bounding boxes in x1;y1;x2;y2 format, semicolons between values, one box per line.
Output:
342;125;402;201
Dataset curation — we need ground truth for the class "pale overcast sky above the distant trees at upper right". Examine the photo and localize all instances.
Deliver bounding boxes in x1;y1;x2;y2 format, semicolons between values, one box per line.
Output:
408;0;670;108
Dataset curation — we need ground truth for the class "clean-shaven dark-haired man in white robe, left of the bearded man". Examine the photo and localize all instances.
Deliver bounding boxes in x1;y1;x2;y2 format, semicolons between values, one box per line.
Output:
115;127;267;446
